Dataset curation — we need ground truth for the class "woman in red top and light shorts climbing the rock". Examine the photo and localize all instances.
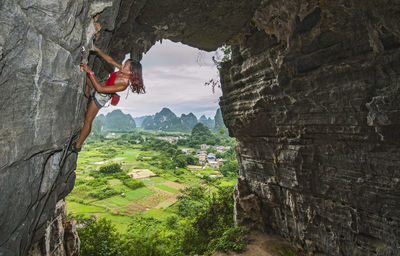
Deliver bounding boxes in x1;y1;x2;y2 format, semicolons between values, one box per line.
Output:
70;45;145;153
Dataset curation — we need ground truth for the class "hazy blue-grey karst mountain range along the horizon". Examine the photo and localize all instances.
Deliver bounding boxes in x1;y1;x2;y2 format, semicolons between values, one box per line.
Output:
93;108;226;132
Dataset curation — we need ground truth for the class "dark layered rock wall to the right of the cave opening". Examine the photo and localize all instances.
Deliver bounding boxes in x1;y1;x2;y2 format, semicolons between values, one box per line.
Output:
220;1;400;255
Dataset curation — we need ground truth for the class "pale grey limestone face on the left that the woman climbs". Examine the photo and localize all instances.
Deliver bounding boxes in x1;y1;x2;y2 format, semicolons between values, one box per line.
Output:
0;0;114;256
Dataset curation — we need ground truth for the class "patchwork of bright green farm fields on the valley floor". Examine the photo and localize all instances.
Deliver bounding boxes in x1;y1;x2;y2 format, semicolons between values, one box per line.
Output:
66;134;236;232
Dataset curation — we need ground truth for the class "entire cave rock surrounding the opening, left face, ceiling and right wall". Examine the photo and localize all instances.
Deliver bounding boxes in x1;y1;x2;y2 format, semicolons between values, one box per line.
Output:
0;0;400;256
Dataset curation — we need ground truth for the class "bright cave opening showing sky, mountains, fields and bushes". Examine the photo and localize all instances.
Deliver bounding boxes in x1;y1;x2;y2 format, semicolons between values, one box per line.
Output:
66;40;244;255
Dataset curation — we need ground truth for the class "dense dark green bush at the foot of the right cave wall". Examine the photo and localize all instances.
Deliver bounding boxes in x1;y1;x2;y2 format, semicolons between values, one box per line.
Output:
178;187;245;255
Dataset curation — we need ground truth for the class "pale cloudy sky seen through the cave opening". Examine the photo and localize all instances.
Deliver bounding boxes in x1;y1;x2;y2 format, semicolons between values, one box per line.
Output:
99;40;222;118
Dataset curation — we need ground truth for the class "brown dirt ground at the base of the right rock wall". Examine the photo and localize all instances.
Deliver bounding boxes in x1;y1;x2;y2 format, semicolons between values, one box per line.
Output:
212;232;304;256
